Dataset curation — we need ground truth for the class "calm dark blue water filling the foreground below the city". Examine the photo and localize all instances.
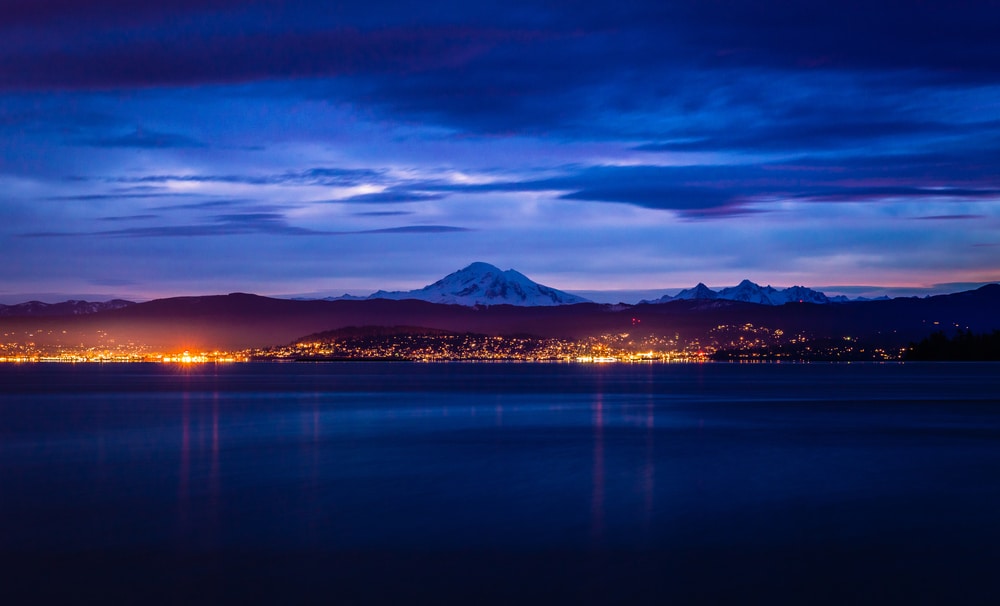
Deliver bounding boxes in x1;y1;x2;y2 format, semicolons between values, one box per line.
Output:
0;363;1000;604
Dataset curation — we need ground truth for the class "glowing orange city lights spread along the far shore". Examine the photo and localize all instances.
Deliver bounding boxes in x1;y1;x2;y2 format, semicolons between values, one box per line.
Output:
0;324;907;364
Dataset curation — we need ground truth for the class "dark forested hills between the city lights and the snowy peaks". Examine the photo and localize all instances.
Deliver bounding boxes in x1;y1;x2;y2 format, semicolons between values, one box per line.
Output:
0;284;1000;351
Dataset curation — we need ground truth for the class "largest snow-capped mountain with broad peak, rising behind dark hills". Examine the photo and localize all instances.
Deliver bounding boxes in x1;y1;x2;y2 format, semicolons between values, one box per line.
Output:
368;262;589;307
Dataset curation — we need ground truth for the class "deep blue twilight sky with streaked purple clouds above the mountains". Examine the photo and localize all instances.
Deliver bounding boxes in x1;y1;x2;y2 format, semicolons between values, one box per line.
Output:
0;0;1000;302
